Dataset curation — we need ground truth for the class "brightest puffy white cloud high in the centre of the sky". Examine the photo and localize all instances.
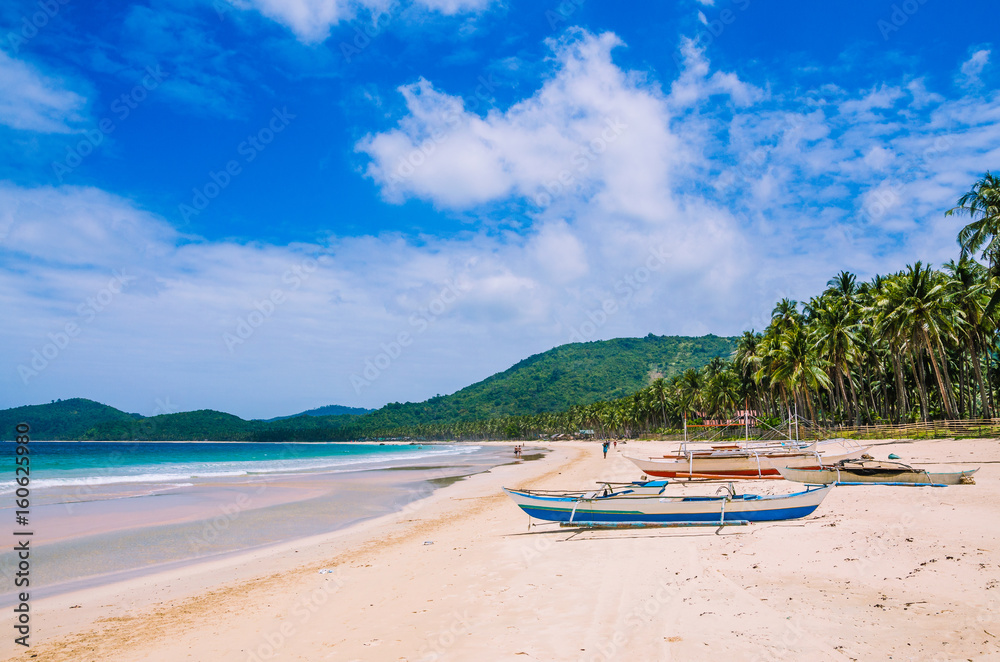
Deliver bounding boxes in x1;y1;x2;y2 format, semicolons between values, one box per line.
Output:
358;31;685;221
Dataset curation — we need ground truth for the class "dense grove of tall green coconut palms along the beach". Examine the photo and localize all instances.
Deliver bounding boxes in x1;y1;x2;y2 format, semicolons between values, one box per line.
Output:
569;172;1000;435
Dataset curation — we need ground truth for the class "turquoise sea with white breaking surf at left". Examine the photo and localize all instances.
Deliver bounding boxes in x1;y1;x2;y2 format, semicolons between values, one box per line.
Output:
0;441;479;496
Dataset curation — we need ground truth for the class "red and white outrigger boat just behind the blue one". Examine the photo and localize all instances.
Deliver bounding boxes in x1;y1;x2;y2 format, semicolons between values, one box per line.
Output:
625;440;870;480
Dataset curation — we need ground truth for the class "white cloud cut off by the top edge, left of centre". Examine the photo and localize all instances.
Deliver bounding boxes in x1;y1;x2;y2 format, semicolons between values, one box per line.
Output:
239;0;491;43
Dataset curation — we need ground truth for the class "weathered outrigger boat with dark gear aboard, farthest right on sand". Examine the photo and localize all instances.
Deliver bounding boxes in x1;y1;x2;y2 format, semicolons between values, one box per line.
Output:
778;459;979;486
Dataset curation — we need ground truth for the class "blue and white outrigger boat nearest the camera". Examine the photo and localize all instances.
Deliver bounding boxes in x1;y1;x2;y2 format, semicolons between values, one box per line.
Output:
504;481;831;528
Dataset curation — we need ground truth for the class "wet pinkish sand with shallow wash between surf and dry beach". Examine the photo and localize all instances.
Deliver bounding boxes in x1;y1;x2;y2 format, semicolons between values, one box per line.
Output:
0;444;528;608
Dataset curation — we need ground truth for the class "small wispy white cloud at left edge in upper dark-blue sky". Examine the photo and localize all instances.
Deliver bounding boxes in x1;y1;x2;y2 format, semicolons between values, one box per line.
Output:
0;50;86;133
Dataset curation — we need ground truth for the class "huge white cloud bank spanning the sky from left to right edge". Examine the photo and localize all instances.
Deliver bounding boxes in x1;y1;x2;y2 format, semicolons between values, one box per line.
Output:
0;31;1000;416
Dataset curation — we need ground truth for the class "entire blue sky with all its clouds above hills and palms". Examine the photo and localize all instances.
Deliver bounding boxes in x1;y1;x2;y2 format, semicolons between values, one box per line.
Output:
0;0;1000;417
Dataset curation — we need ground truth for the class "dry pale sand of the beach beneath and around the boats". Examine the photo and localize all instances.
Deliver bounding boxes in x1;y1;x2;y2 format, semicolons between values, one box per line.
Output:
0;440;1000;662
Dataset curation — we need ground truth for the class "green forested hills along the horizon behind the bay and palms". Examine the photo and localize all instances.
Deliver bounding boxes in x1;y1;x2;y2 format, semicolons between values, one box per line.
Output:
0;335;736;441
